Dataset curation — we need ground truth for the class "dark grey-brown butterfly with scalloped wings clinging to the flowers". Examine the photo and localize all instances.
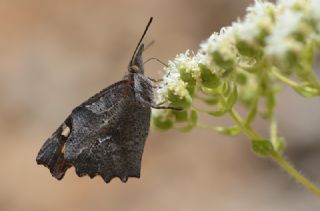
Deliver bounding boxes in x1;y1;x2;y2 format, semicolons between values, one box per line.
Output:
36;17;178;183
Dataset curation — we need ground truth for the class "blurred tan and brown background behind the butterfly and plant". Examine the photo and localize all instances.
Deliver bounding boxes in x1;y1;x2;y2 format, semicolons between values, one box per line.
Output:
0;0;320;211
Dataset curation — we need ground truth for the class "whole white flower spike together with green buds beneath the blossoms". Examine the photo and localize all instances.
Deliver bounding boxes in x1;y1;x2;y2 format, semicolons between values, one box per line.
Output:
155;0;320;129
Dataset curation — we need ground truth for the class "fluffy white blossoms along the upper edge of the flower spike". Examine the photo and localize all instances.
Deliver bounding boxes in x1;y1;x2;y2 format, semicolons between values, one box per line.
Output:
157;0;320;101
